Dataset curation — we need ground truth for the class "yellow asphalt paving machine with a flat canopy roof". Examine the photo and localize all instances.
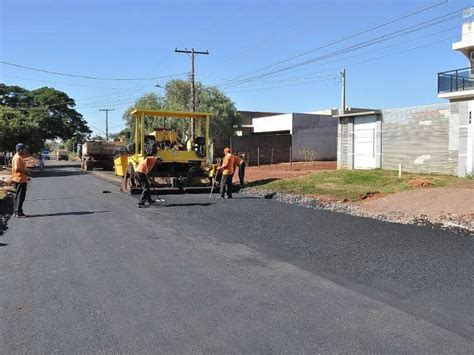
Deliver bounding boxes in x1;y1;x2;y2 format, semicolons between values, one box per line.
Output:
115;110;217;193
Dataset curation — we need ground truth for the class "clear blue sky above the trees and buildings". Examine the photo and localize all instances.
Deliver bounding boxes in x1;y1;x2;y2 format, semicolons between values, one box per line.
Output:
0;0;474;137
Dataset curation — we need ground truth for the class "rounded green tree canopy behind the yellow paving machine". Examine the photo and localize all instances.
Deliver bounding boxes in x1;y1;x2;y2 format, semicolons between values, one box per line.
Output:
123;80;240;143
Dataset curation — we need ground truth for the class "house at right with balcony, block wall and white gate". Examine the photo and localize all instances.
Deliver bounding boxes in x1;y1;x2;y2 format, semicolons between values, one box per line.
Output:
335;9;474;176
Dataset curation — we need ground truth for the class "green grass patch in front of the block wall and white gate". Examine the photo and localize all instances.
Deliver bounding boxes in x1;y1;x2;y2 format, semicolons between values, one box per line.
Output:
261;169;466;201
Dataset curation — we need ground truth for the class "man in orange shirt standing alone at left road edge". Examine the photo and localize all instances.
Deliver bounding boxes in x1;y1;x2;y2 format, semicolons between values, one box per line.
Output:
12;143;30;218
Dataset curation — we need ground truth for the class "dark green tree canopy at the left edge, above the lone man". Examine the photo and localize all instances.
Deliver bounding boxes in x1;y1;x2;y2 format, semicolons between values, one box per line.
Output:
0;84;91;151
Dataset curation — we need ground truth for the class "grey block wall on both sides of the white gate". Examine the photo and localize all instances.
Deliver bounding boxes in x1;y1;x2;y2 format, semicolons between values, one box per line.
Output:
338;101;474;176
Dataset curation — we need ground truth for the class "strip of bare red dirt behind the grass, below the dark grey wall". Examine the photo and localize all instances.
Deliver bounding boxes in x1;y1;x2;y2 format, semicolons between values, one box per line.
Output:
241;161;336;182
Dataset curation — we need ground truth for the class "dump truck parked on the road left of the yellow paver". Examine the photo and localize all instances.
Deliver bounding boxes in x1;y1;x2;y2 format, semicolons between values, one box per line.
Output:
81;141;125;171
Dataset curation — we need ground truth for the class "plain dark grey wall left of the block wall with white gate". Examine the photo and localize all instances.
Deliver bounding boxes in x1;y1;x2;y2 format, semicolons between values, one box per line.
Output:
292;113;337;161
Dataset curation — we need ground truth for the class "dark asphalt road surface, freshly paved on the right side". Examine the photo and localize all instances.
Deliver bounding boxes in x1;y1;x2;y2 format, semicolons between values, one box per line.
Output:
0;167;474;354
